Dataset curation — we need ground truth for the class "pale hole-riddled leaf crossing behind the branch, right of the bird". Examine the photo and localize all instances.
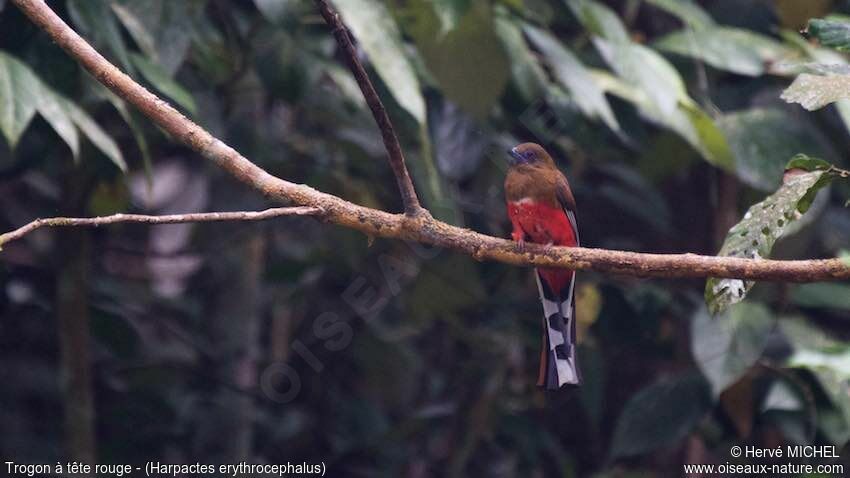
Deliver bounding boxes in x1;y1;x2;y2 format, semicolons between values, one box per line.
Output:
705;164;837;314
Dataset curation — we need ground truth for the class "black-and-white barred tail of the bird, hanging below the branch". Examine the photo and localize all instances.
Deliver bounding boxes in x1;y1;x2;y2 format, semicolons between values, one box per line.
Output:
535;272;581;390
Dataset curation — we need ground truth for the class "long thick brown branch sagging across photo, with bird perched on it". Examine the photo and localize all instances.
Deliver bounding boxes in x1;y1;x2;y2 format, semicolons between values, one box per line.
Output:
11;0;850;282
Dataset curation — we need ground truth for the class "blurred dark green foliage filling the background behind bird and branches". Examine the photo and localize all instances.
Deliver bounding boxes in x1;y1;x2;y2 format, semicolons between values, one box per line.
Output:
0;0;850;477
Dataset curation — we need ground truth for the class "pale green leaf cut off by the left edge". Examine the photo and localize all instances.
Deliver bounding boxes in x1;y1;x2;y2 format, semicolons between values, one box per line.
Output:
0;52;41;148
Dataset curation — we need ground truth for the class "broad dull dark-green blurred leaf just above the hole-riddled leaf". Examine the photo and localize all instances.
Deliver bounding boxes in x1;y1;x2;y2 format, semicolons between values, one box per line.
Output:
717;108;831;191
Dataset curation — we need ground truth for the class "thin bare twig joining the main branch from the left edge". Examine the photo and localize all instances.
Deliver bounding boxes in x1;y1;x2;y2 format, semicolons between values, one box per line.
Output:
0;206;322;250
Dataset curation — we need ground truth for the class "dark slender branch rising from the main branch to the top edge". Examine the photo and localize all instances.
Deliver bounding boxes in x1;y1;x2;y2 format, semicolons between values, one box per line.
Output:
315;0;423;216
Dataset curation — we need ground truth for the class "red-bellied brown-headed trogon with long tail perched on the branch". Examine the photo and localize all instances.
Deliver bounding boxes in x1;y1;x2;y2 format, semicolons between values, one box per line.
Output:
505;143;582;390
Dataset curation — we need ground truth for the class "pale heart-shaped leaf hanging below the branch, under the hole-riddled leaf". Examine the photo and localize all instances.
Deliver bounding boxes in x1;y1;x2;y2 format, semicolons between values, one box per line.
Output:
691;302;776;398
